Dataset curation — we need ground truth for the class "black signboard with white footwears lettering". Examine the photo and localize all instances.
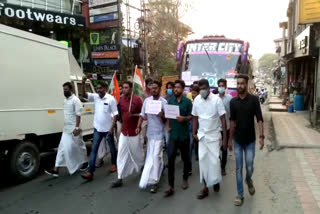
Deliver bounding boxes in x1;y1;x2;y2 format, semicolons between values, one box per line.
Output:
0;2;85;27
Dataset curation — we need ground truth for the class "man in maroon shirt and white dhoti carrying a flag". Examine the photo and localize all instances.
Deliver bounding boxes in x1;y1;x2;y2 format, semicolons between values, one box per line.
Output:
111;82;144;188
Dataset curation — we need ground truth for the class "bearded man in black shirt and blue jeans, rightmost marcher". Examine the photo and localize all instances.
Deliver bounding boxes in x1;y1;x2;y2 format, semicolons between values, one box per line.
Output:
229;75;264;206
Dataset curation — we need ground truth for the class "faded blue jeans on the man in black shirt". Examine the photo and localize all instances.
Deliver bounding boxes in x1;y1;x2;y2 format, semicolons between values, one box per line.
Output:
233;141;256;197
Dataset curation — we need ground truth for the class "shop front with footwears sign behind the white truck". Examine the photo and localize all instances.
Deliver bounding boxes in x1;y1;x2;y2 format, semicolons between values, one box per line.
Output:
0;0;89;61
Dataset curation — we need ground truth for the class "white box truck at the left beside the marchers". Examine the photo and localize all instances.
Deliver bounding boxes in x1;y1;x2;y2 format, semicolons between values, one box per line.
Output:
0;24;94;181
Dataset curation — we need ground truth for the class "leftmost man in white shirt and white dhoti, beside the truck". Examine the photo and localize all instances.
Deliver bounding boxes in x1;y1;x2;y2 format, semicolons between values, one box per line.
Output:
45;82;87;177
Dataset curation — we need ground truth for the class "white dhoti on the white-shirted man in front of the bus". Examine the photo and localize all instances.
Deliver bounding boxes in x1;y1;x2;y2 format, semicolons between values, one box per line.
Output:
199;136;222;187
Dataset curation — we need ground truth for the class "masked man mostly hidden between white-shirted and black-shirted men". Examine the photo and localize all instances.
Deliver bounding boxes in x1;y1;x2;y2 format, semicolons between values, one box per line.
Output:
218;79;232;176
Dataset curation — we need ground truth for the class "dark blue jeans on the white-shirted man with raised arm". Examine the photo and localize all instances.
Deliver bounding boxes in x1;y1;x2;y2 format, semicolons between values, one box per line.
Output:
89;129;117;174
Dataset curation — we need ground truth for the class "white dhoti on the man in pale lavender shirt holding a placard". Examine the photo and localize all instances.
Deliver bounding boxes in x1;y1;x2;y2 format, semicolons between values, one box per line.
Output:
139;139;163;189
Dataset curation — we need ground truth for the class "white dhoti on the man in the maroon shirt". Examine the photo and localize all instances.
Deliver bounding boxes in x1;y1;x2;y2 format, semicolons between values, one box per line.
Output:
117;133;144;179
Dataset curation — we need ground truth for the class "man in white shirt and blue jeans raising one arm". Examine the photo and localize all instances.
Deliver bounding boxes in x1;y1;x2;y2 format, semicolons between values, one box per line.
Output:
81;77;118;180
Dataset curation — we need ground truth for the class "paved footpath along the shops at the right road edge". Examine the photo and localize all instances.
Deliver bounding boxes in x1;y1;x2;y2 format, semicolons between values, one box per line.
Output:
272;113;320;214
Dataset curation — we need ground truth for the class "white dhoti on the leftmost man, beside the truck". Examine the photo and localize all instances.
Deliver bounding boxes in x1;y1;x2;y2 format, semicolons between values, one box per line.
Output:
55;132;87;174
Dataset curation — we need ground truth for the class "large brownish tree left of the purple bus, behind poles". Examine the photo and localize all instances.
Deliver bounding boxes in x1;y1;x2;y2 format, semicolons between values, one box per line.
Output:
147;0;192;77
